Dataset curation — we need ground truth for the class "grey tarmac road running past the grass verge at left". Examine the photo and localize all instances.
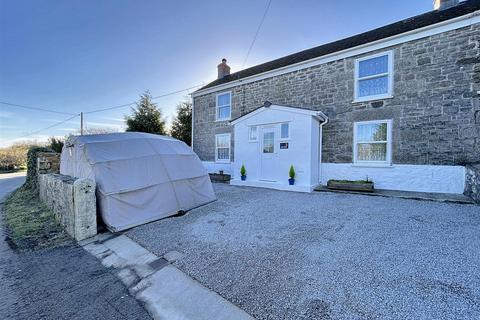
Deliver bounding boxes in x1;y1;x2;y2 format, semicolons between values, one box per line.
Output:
0;174;150;320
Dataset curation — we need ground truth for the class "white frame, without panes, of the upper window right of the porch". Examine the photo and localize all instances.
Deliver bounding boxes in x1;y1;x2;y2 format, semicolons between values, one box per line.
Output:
353;50;394;103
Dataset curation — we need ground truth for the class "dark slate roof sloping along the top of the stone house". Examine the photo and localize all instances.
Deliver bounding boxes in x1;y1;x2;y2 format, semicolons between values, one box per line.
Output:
197;0;480;91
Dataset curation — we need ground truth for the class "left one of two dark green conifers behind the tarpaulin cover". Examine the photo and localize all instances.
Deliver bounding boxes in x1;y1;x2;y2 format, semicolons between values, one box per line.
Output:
125;91;165;134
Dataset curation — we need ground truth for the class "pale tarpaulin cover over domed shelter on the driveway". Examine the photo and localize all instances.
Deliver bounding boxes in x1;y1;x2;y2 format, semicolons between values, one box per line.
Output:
60;132;216;232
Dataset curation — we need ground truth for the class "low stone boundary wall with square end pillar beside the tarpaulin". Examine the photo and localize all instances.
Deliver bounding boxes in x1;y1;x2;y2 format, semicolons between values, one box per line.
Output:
38;173;97;241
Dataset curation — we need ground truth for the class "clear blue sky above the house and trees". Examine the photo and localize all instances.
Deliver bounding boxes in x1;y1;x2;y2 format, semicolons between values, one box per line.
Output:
0;0;433;147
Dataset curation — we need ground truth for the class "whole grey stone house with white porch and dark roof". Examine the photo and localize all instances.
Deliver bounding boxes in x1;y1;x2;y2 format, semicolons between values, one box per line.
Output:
192;0;480;193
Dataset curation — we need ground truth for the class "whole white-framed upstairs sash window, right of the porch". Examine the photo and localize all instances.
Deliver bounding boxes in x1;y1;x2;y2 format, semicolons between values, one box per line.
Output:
355;51;393;101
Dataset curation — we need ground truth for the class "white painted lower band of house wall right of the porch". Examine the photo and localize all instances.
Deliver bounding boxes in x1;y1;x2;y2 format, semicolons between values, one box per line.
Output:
322;163;465;194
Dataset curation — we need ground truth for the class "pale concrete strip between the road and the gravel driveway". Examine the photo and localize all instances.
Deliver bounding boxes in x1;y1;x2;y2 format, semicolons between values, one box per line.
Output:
79;233;254;320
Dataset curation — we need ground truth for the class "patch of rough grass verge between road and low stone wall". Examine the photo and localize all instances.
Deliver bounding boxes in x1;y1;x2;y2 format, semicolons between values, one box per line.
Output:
3;187;73;251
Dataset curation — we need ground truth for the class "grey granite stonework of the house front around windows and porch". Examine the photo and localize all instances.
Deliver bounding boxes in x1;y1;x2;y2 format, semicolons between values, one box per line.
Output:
193;25;480;165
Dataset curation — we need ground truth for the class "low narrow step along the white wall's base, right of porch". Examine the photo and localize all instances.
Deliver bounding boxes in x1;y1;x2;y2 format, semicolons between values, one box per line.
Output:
315;186;475;204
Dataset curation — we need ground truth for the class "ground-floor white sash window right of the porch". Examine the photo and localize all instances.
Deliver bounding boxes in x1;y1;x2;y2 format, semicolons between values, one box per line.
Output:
353;120;392;165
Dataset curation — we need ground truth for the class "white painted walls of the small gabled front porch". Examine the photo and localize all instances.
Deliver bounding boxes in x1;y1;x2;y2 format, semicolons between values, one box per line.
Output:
233;108;320;190
